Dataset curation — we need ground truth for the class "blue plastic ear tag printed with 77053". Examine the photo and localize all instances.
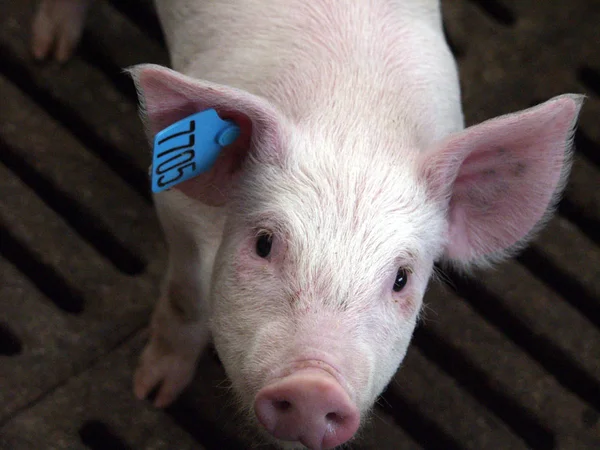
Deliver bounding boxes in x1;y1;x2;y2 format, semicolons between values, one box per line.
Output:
151;109;240;192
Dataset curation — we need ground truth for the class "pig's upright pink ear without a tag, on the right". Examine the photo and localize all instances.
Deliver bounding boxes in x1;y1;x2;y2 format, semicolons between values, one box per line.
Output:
420;95;583;268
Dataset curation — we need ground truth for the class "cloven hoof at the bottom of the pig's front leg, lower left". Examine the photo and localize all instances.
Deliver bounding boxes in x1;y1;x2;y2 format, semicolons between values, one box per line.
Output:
133;340;196;408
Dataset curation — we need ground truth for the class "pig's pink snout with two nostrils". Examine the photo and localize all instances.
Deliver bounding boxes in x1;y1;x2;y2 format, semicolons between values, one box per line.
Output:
254;369;360;450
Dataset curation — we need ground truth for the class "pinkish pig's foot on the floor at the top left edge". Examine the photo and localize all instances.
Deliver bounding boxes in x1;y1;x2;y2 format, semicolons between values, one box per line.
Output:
31;0;91;62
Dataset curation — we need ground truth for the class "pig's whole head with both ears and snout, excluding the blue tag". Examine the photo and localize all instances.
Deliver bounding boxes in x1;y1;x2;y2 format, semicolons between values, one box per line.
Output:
133;66;581;449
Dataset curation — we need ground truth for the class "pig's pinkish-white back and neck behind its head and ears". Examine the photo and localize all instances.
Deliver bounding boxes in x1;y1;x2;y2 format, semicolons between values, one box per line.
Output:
157;0;463;147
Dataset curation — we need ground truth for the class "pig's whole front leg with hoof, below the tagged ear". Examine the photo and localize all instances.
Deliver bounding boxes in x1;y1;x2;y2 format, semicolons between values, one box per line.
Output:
134;192;216;408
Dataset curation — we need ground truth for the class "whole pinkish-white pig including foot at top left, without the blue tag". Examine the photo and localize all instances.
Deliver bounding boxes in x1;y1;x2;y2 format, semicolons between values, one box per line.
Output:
32;0;583;449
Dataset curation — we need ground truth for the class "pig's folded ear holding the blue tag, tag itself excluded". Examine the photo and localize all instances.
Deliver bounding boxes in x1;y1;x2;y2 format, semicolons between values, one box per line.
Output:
128;64;282;206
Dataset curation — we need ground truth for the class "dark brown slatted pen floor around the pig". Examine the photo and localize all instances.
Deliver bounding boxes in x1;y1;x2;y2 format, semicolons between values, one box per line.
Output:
0;0;600;450
